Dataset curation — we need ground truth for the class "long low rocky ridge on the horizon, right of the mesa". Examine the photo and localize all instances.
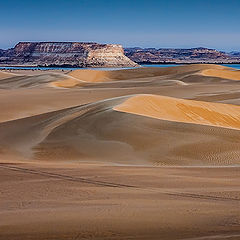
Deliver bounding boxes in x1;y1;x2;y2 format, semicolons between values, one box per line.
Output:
125;47;240;63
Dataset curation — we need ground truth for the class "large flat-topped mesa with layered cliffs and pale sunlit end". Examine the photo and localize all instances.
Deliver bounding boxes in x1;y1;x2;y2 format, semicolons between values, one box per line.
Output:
0;42;137;67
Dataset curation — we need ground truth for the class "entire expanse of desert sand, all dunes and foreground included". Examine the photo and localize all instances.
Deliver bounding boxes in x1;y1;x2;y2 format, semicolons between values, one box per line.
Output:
0;64;240;240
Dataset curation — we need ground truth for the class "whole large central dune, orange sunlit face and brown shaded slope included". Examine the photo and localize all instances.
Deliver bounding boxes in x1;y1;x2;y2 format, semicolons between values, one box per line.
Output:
0;95;240;166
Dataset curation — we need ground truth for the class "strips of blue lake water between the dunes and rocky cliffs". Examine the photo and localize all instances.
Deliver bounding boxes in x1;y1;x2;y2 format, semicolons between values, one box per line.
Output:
0;64;240;71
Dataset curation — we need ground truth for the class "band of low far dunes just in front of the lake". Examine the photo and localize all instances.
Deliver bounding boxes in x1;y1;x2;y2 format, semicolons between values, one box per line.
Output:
0;64;236;89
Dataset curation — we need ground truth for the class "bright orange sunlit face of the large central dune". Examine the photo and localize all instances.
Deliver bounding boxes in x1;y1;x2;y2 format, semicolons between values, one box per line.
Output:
114;95;240;129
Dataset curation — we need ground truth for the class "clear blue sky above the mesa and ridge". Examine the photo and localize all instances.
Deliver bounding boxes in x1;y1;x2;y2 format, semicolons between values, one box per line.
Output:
0;0;240;51
